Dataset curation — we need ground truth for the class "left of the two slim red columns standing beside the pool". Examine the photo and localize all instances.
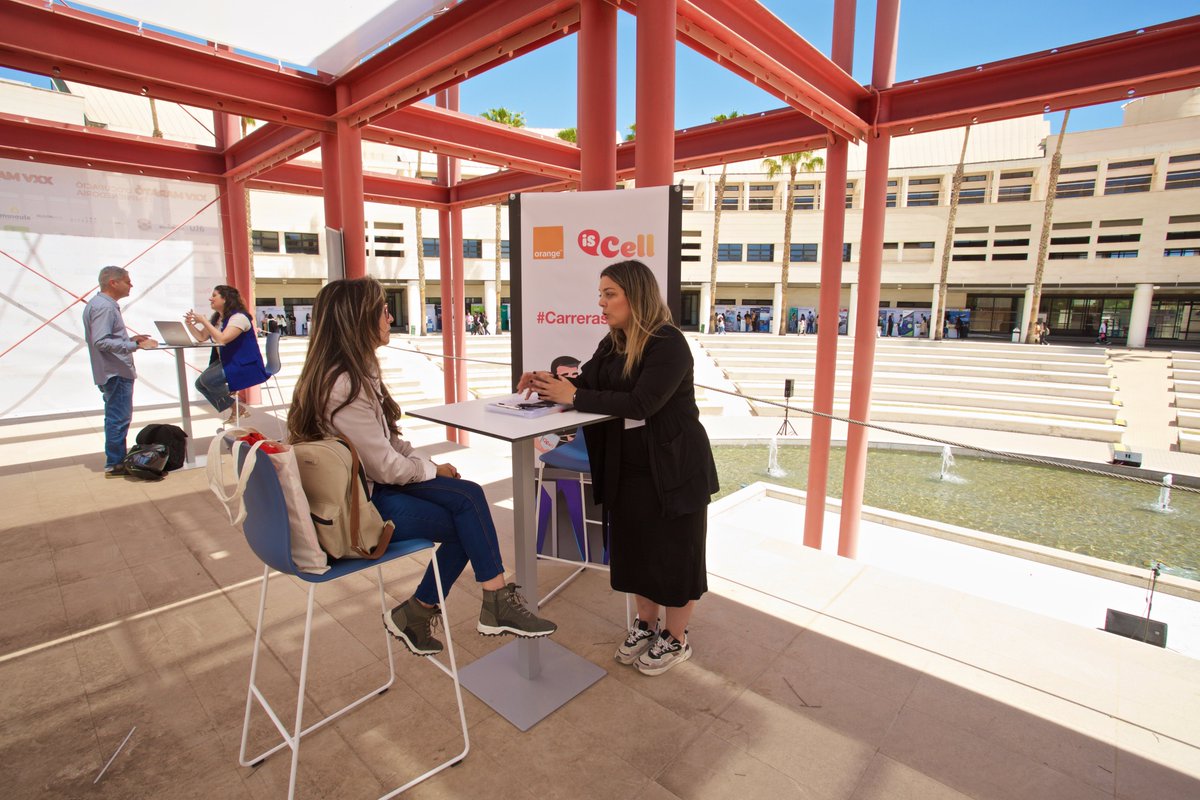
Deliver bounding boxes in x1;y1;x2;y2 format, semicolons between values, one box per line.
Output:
804;0;854;549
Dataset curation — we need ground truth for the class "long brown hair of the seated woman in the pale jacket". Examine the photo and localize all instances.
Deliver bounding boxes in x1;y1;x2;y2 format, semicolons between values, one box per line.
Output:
288;277;400;441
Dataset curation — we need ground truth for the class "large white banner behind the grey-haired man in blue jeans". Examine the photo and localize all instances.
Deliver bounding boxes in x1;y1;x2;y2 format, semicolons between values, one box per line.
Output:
0;160;226;419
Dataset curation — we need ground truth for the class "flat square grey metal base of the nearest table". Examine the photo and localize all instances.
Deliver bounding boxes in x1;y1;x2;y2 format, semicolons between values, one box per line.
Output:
458;639;605;730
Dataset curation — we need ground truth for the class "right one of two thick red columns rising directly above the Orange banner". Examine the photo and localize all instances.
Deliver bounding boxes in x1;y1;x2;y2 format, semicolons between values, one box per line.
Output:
634;0;676;187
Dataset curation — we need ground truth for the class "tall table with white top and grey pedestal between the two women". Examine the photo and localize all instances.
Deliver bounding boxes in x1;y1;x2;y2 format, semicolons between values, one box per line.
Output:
406;397;612;730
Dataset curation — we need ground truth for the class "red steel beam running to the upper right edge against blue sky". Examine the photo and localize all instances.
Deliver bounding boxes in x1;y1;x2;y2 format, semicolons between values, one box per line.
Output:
880;17;1200;136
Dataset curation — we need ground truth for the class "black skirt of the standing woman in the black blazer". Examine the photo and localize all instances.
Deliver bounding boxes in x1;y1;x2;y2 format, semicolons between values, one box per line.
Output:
605;427;708;607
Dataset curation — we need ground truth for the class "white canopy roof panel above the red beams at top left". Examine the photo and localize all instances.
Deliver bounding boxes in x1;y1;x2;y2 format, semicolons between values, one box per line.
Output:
86;0;455;74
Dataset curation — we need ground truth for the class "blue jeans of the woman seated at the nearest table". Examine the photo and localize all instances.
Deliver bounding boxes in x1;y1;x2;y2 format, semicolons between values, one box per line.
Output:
371;476;504;606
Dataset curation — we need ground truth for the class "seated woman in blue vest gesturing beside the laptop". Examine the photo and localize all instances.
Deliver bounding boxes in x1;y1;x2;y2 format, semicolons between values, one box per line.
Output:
184;284;270;422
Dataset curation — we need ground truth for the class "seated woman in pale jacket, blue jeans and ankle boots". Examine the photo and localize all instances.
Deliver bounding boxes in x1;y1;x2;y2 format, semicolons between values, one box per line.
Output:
288;278;557;655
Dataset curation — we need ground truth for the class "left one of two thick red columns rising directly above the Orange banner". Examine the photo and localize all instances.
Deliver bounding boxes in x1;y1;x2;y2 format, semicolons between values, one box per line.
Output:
576;0;619;192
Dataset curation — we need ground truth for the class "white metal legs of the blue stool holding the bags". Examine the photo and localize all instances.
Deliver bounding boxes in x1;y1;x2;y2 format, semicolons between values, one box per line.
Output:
238;559;470;800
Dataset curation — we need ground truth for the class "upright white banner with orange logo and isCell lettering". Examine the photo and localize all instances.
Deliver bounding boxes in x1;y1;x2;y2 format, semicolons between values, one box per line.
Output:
509;186;683;385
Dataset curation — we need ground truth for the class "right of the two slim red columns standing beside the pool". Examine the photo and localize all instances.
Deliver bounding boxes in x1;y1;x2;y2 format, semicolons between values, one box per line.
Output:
838;0;900;558
